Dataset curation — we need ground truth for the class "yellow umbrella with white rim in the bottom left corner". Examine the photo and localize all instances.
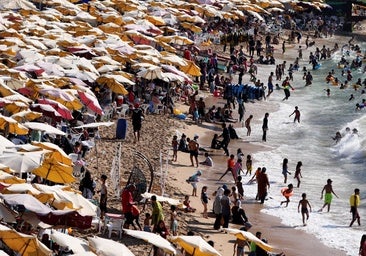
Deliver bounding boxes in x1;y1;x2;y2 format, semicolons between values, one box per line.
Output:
0;224;52;256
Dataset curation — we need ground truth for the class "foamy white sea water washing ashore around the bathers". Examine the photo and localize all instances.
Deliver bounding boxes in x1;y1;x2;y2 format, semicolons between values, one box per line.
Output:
237;45;366;256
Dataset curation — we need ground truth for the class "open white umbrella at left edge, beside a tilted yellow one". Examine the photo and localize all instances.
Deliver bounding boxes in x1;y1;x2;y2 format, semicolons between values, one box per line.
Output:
0;151;44;173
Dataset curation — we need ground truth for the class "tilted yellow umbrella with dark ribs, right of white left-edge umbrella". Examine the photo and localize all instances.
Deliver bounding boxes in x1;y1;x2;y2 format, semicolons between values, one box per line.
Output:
32;158;75;184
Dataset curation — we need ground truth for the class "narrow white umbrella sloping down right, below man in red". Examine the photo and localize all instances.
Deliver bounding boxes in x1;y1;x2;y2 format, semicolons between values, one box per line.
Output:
123;229;177;255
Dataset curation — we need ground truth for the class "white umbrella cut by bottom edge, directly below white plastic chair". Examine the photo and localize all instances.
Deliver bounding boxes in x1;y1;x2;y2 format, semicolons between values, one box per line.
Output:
88;236;135;256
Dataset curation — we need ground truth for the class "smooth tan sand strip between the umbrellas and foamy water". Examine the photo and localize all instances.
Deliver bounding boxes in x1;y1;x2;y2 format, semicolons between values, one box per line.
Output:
169;95;346;256
